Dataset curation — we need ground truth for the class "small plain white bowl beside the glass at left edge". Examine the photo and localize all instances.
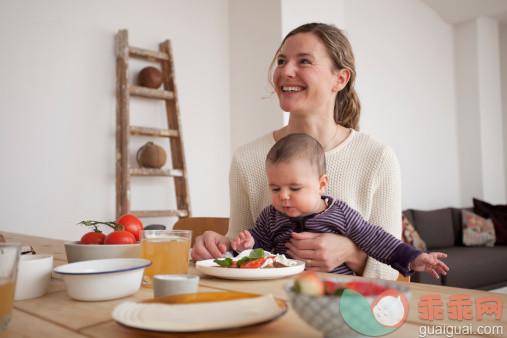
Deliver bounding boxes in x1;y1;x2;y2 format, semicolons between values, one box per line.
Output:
14;255;53;300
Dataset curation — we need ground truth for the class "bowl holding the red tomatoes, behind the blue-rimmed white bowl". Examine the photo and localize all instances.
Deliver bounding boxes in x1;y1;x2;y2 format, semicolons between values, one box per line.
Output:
64;242;141;263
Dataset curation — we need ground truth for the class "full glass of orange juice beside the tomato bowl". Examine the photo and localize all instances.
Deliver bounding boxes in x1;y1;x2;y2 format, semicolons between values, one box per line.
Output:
139;230;192;286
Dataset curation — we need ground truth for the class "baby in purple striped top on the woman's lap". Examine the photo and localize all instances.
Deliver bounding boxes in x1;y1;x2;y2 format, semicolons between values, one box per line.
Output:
231;134;449;278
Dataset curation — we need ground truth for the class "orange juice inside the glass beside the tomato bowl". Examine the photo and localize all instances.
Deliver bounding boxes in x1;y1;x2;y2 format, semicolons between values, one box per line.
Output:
141;237;190;284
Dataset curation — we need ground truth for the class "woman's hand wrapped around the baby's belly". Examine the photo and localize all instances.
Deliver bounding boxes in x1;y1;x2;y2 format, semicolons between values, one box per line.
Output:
285;232;368;275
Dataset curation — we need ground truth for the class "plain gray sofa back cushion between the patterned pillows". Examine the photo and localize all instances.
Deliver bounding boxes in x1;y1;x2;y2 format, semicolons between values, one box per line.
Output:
409;208;455;250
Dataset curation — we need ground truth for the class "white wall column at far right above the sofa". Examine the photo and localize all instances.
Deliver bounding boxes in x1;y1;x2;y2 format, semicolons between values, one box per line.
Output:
455;17;505;204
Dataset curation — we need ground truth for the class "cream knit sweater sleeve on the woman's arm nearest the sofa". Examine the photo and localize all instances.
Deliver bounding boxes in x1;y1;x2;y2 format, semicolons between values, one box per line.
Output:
363;147;401;280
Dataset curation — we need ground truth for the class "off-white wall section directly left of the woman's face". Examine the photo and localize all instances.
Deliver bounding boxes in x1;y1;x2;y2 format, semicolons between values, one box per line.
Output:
229;0;283;151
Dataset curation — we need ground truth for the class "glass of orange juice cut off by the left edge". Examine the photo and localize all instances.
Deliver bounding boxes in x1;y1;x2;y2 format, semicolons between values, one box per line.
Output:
0;243;21;330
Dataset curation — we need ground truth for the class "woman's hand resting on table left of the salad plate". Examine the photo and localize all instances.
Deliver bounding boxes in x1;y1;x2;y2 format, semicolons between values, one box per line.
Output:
191;231;231;262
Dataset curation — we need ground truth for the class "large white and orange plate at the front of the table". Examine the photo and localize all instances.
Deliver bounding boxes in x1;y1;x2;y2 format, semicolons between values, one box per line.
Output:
112;292;288;332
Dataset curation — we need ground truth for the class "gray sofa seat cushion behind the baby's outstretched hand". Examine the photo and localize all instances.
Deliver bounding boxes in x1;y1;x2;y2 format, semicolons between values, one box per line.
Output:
432;246;507;289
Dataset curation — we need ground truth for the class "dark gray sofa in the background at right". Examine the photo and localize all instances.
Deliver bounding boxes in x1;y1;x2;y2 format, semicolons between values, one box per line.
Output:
403;208;507;290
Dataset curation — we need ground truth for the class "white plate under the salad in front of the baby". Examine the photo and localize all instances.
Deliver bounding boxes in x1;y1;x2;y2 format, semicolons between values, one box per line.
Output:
195;259;305;280
